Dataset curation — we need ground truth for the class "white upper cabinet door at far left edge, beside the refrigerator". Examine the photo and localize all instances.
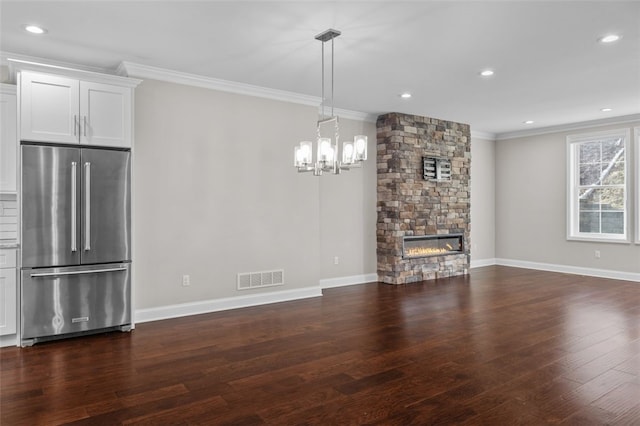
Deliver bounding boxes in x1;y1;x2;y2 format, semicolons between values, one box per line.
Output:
0;93;18;192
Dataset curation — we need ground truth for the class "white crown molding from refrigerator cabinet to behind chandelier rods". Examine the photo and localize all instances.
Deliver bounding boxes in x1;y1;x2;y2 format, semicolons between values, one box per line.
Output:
116;62;320;106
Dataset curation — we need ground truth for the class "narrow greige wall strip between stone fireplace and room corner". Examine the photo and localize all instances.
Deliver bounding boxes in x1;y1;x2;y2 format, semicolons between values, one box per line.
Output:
471;134;496;267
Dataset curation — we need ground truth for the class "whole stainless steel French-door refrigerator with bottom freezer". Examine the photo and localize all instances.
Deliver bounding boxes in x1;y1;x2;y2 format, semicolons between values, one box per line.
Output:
20;142;131;346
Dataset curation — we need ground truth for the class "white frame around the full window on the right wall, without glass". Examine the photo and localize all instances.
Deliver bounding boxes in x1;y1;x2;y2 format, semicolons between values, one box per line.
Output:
567;128;640;243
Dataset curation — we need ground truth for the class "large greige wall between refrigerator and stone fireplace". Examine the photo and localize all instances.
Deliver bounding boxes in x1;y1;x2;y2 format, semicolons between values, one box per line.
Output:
133;80;376;309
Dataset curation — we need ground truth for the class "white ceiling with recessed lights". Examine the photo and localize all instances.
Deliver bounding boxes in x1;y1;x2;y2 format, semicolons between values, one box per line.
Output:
0;0;640;136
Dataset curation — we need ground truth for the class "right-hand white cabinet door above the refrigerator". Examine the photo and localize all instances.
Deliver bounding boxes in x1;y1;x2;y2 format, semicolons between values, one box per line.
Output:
80;81;131;147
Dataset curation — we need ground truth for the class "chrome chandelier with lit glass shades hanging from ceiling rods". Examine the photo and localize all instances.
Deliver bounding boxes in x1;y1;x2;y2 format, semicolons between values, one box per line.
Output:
293;29;367;176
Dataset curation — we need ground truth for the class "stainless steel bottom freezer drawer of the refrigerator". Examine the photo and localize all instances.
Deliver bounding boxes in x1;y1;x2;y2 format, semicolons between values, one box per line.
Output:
21;263;131;340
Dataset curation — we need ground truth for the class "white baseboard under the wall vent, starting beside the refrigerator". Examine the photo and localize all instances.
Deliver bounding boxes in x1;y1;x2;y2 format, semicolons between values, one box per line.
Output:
135;287;322;323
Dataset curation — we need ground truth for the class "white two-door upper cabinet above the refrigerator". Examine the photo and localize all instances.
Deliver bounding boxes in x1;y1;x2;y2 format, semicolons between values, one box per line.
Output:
20;71;133;147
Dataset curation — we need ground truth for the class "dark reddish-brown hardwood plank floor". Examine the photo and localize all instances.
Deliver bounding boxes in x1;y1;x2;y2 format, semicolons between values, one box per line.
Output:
0;267;640;426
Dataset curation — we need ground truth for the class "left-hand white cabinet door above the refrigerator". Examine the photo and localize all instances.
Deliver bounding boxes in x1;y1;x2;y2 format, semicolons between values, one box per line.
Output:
20;71;80;143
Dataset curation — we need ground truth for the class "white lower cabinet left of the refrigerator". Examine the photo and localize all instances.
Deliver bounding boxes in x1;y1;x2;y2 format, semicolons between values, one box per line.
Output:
0;249;18;336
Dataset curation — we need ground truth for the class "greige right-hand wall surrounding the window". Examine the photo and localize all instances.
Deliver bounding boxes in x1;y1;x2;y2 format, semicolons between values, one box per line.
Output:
496;122;640;273
